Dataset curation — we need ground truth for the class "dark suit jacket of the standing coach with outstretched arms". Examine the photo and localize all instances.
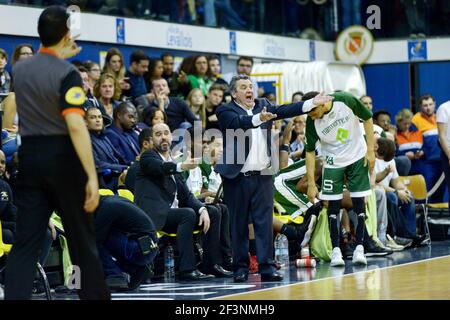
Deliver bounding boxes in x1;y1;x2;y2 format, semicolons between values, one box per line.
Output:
215;98;303;179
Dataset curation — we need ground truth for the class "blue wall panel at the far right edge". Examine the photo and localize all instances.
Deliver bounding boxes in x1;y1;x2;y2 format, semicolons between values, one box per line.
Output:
418;62;450;108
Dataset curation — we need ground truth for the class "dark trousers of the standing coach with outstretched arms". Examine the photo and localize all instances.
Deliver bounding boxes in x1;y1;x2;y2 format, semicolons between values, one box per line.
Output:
223;175;275;275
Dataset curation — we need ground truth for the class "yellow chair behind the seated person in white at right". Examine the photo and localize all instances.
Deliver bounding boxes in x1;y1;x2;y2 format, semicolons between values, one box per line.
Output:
399;174;440;244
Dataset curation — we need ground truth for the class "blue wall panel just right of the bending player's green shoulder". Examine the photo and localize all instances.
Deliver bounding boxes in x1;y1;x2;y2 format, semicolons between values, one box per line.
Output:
363;63;411;122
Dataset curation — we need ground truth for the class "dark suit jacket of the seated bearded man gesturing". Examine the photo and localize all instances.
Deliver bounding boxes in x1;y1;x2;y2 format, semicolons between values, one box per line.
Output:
134;149;203;230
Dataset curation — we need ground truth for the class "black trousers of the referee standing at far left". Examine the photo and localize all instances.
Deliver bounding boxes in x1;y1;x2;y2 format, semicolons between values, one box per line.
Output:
5;136;110;300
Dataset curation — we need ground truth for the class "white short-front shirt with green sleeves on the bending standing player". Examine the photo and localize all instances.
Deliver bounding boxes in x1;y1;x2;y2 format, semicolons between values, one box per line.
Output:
306;92;372;168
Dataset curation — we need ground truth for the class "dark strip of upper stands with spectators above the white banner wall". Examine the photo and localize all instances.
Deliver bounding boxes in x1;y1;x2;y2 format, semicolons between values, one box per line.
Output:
0;0;450;40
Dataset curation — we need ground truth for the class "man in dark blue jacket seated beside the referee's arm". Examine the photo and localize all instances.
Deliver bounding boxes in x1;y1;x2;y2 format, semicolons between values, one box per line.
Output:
85;107;128;190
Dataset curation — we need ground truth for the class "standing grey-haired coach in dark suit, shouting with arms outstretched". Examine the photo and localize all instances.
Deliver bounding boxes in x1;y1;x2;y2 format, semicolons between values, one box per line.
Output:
216;75;331;282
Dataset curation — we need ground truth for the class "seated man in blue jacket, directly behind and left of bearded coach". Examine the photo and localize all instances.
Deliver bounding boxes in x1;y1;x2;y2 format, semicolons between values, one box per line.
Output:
106;102;140;165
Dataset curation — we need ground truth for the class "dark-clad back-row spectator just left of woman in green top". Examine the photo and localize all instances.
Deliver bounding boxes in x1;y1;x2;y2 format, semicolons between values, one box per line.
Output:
161;52;191;99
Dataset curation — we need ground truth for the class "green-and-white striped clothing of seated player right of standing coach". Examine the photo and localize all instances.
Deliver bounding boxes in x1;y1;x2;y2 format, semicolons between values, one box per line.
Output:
273;159;312;219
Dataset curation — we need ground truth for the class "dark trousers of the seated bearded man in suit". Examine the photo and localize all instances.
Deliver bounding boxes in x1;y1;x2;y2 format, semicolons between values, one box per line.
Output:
162;208;198;272
